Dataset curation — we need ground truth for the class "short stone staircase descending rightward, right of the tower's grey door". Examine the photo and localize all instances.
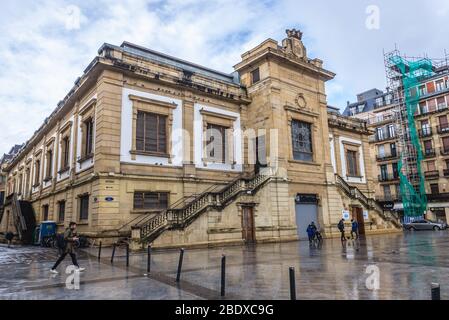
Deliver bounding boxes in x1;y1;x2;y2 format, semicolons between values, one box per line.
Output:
335;174;402;228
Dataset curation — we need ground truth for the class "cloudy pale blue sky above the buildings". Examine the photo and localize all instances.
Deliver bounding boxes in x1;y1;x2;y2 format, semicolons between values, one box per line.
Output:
0;0;449;154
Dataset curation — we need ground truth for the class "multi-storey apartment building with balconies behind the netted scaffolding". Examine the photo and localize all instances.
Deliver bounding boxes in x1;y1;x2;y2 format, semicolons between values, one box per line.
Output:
343;67;449;221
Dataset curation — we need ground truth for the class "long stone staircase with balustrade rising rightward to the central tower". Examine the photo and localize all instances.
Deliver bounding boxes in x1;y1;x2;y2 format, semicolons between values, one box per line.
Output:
131;173;271;244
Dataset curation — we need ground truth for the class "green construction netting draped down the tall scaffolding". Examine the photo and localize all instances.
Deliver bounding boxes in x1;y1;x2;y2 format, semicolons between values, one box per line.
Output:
390;56;434;217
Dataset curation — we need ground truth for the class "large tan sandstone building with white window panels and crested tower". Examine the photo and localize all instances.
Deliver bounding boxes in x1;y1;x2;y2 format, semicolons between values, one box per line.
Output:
1;30;397;247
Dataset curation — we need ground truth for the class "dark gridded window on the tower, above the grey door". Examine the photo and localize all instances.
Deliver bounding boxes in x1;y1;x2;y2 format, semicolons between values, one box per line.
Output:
292;120;313;161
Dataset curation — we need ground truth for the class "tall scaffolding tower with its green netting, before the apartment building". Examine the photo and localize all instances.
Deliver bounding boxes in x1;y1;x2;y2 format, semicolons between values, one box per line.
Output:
384;49;434;222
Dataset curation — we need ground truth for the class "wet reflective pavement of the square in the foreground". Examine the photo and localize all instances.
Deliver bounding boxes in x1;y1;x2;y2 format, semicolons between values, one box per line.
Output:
0;231;449;300
